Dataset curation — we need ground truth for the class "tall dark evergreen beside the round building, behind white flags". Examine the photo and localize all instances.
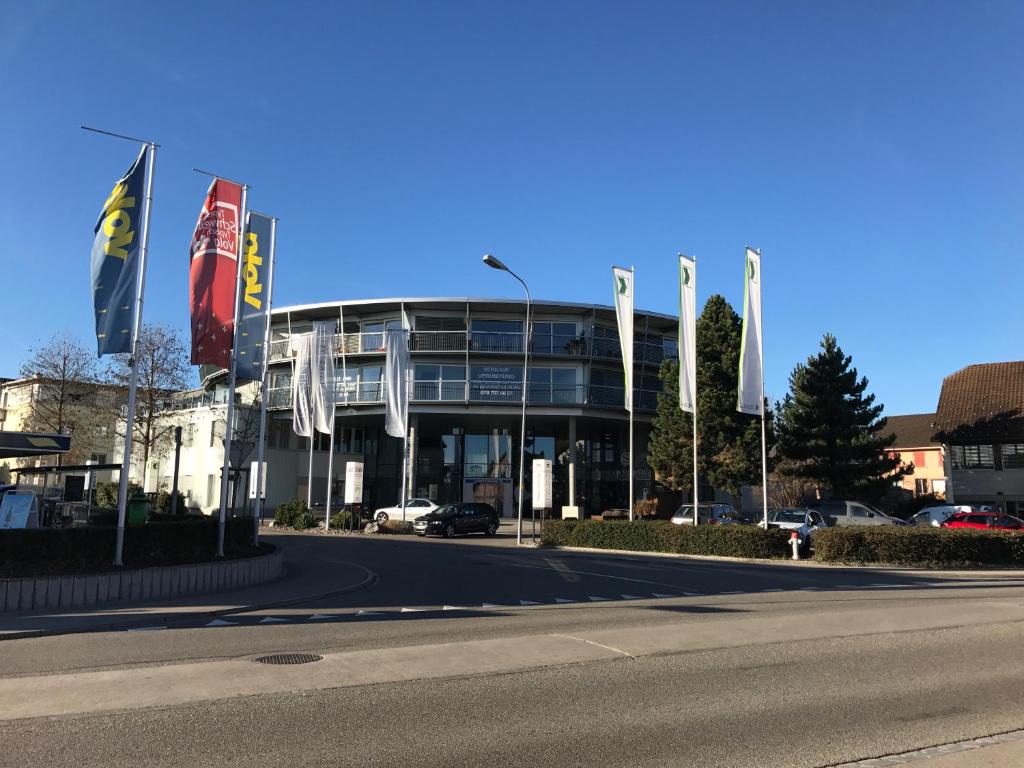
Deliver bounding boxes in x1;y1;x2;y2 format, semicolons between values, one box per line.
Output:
647;295;772;497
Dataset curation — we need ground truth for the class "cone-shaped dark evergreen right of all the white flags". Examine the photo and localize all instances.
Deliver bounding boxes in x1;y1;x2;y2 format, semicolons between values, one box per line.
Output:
778;334;912;500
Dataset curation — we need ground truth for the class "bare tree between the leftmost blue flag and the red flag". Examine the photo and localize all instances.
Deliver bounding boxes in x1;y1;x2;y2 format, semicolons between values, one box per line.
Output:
109;326;191;472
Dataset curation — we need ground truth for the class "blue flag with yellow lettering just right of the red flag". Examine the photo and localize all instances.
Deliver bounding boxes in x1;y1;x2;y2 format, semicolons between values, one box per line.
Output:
234;212;273;382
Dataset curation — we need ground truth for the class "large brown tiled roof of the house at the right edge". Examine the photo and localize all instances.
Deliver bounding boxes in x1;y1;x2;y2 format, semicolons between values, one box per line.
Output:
935;360;1024;442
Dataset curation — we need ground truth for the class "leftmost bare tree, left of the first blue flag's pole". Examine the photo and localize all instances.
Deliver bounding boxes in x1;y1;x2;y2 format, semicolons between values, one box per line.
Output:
20;334;109;464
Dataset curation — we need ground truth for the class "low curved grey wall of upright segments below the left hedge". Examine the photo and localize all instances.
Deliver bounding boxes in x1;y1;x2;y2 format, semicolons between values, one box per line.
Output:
0;550;285;611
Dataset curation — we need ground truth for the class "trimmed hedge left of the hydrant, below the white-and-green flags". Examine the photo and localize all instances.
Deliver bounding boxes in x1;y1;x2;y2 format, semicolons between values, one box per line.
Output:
541;520;790;558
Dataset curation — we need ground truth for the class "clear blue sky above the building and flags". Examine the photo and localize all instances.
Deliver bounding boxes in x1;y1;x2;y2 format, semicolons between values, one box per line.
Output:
0;0;1024;414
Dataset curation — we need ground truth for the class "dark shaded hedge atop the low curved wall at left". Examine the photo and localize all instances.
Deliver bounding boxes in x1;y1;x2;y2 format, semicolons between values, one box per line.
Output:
0;518;259;579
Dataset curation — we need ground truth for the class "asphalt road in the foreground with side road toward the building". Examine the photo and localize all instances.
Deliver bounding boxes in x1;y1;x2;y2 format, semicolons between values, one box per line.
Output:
0;536;1024;766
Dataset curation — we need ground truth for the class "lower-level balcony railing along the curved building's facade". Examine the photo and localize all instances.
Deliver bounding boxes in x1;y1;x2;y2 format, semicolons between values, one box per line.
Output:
267;381;657;411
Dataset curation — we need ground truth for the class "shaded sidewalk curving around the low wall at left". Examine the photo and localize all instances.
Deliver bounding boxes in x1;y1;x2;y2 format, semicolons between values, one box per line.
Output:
0;532;377;640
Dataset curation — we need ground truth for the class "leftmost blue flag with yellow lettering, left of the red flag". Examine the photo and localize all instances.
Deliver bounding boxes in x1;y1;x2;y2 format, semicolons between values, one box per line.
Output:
92;146;147;356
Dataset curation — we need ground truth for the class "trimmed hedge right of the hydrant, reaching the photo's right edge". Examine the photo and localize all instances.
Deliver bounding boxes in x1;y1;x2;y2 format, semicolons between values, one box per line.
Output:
812;525;1024;567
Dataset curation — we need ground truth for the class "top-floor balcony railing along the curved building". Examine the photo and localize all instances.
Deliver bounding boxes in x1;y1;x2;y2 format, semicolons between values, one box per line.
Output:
270;331;673;366
